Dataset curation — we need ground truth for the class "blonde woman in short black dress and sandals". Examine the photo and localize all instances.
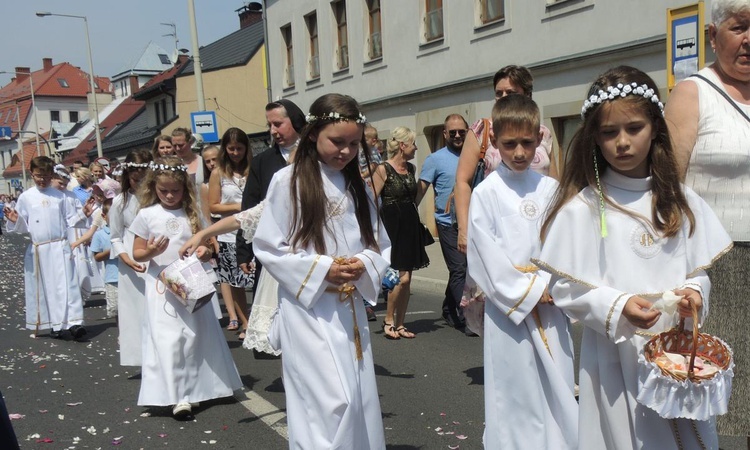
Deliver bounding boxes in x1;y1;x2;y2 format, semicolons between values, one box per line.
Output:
372;127;430;339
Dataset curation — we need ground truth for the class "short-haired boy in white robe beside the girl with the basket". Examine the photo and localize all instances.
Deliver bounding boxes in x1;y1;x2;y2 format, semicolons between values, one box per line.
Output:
467;95;578;449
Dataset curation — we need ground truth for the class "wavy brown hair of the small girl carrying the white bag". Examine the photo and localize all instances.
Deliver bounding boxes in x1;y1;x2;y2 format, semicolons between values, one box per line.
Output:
138;156;202;234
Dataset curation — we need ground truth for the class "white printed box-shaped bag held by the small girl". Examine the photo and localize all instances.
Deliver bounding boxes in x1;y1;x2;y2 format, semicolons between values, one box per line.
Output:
156;254;218;313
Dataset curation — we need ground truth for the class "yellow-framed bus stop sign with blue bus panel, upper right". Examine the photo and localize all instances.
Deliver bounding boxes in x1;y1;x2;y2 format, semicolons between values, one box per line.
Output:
667;1;706;91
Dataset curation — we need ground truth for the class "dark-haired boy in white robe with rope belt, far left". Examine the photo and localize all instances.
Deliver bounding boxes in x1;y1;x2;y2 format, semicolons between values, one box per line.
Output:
5;156;86;339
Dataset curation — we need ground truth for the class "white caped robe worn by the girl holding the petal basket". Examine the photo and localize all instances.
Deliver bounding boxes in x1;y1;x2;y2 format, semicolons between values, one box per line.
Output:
536;170;732;450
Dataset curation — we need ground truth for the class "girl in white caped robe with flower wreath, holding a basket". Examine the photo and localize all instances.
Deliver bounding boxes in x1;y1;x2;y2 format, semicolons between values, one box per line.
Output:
536;66;732;450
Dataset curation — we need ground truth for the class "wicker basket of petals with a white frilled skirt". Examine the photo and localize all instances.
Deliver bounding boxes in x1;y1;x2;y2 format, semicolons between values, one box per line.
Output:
637;301;734;420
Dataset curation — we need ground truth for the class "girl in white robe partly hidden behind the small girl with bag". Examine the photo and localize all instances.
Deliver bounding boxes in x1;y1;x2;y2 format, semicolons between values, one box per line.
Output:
109;150;151;366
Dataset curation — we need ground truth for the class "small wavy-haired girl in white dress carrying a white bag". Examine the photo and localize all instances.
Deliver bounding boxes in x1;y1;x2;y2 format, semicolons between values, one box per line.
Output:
130;156;242;419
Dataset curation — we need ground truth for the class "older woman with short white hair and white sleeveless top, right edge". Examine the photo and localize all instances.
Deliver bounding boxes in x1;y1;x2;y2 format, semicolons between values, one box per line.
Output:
665;0;750;442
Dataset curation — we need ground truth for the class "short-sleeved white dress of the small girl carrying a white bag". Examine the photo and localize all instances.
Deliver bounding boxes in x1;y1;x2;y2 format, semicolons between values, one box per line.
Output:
130;204;242;406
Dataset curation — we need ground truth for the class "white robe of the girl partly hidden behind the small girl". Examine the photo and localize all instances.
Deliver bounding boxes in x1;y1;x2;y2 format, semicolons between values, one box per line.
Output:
109;193;146;366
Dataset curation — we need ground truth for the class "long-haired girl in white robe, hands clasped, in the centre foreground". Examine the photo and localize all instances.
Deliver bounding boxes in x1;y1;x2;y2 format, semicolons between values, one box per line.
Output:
253;94;390;449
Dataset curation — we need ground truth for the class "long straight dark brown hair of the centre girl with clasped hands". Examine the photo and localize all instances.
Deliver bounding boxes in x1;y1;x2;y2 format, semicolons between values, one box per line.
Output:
290;94;380;254
